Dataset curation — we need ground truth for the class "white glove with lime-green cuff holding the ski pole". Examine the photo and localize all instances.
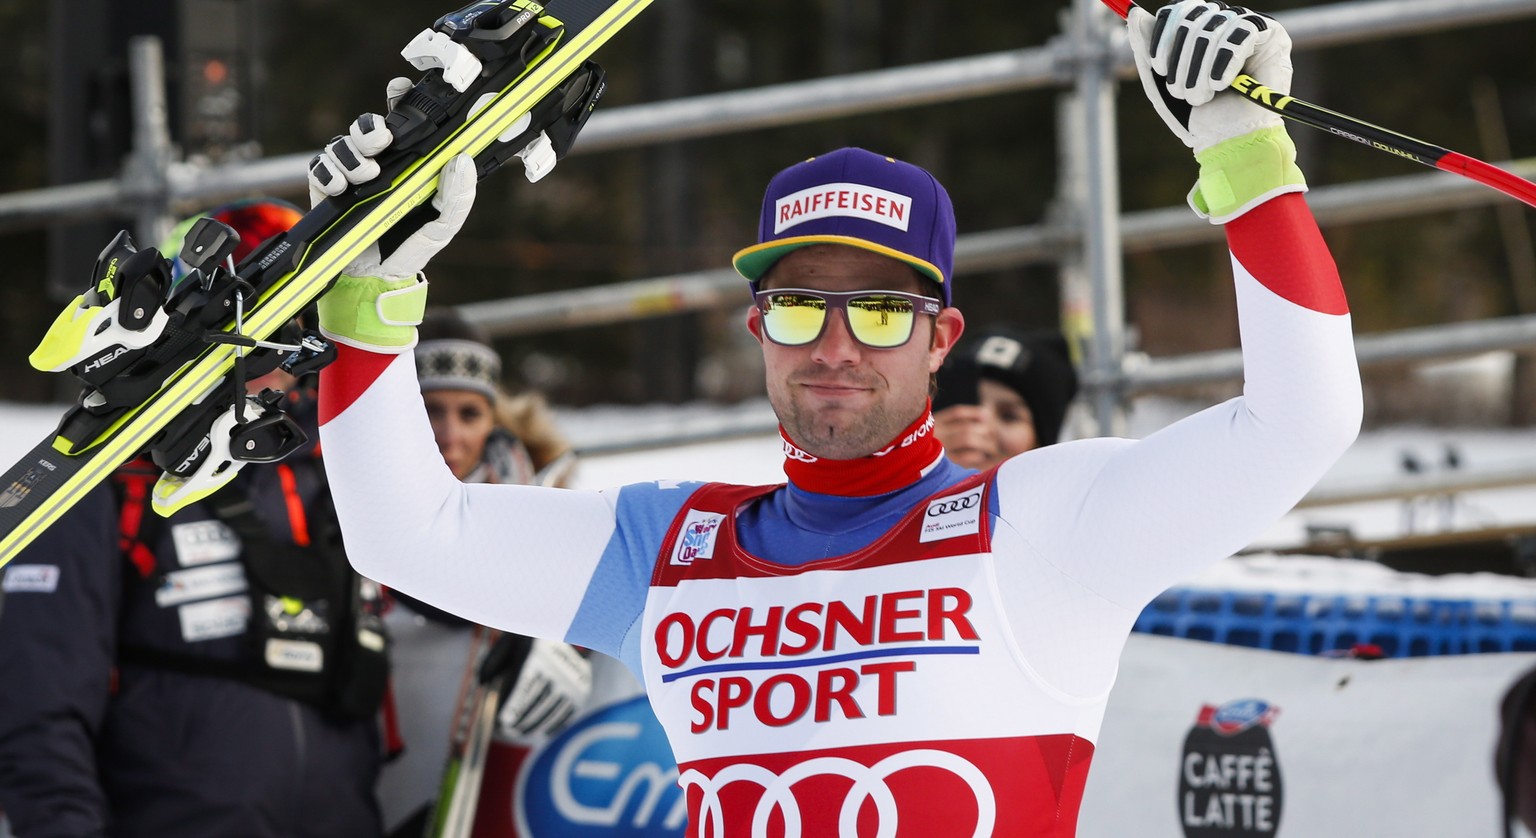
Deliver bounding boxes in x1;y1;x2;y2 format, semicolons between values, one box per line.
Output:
1126;0;1307;224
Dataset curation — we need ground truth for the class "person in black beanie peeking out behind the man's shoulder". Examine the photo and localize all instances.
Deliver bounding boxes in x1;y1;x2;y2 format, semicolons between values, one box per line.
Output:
934;328;1077;470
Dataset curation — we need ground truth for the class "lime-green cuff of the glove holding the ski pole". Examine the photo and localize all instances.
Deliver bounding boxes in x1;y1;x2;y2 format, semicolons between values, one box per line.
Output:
1189;126;1307;224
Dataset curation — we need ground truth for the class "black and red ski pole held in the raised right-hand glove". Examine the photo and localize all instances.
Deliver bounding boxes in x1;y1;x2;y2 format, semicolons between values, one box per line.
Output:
1103;0;1536;207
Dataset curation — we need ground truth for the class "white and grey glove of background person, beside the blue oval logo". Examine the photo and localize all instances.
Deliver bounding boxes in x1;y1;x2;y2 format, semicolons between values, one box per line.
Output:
496;638;591;740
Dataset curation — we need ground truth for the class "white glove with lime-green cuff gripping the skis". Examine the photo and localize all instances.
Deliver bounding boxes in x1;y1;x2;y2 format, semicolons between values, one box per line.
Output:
309;78;476;353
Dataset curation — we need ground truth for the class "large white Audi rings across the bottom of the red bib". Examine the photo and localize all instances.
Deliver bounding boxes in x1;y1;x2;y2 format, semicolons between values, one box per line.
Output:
677;749;997;838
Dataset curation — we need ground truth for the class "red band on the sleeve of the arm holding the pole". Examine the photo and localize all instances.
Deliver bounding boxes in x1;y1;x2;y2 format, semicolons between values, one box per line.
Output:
1226;193;1349;315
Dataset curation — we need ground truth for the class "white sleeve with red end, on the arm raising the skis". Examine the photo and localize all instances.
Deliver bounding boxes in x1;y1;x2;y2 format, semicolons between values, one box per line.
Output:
321;347;614;638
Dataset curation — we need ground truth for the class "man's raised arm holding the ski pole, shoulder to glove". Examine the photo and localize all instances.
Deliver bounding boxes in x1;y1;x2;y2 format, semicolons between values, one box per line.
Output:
998;2;1361;601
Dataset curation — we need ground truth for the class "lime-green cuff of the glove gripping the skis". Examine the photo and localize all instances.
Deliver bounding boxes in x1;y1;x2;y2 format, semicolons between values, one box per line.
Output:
318;275;427;353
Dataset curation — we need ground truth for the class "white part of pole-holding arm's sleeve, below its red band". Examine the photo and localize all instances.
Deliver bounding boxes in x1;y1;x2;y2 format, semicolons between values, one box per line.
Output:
997;270;1361;608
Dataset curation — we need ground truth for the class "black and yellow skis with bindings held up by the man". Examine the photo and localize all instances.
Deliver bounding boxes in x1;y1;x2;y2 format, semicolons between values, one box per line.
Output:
0;0;651;566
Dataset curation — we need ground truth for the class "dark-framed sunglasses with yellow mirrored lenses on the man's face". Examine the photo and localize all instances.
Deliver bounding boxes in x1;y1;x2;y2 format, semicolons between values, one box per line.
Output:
753;289;943;348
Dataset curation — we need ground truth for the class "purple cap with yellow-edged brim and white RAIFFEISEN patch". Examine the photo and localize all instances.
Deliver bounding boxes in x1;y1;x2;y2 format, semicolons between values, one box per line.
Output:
731;149;955;305
